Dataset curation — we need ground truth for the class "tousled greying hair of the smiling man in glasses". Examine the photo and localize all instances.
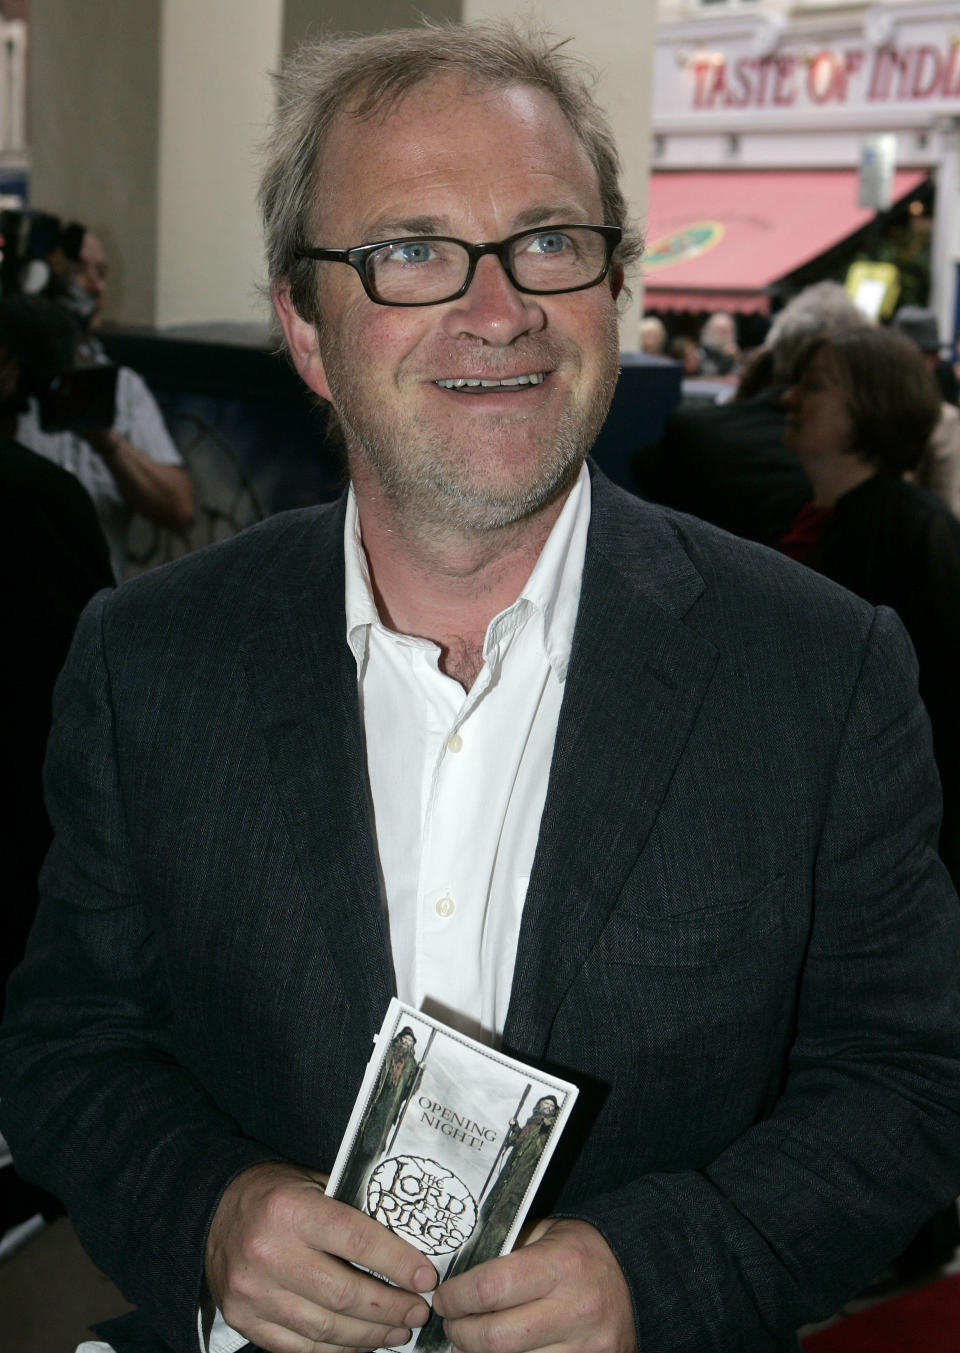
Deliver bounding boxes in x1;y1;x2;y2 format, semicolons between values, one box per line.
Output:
260;20;642;322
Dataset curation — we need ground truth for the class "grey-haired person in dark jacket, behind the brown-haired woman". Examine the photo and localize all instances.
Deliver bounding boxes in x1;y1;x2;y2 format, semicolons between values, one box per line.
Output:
633;281;867;545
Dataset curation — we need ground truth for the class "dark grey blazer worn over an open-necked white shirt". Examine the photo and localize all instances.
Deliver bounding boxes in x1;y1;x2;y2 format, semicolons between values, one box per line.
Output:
0;475;960;1353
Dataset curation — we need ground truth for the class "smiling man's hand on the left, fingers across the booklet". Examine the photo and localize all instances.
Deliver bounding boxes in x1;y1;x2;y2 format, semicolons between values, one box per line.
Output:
206;1165;437;1353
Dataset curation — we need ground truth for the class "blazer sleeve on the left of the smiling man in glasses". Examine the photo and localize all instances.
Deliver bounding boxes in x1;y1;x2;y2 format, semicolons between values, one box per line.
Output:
0;595;277;1349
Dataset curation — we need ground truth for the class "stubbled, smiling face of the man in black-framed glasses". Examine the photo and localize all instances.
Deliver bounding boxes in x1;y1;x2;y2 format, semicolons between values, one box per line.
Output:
280;76;619;530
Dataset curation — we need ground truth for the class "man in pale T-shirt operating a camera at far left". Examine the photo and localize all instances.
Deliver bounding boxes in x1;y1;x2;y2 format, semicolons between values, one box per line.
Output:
16;223;193;579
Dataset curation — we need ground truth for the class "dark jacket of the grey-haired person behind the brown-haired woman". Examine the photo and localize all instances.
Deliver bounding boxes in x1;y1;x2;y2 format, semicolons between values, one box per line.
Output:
633;387;811;545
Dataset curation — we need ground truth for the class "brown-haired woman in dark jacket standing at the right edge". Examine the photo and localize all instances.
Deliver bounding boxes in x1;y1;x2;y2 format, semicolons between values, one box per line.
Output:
780;327;960;1288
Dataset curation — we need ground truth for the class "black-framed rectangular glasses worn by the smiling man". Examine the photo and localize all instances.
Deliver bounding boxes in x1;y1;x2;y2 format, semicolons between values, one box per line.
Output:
300;225;622;306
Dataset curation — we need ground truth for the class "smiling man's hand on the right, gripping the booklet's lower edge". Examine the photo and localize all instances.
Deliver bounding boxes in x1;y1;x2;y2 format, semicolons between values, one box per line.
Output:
433;1219;637;1353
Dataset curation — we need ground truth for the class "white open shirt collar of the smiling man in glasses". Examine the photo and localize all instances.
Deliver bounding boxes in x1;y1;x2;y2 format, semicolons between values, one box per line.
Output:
343;465;591;681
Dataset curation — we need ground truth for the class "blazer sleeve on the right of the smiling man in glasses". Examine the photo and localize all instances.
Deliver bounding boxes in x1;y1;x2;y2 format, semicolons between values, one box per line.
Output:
567;609;960;1353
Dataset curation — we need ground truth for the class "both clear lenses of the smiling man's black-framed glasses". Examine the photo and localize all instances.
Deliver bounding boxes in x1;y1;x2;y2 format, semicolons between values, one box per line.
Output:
366;227;607;303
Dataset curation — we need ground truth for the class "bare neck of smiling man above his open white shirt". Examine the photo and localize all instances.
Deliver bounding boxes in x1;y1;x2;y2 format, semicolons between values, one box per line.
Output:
354;479;569;690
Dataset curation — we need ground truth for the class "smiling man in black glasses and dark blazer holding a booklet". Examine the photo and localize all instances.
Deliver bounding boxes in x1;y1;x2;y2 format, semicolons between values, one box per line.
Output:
0;26;960;1353
